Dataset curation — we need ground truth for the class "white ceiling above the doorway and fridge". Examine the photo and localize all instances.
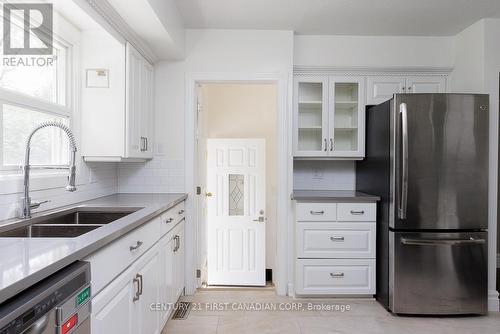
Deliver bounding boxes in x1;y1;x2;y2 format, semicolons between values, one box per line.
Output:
175;0;500;36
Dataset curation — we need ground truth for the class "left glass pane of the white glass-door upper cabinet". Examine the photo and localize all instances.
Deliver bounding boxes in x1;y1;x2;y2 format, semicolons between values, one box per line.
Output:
297;82;323;151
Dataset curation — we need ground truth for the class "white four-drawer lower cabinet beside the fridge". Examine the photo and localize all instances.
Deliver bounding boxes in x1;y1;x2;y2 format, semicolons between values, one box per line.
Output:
295;202;376;296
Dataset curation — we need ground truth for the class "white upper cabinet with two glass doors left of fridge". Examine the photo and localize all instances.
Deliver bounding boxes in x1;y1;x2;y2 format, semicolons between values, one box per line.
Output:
293;76;365;159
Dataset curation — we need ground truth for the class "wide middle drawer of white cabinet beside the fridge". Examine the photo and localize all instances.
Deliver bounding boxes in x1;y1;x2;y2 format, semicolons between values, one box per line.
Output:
297;223;376;259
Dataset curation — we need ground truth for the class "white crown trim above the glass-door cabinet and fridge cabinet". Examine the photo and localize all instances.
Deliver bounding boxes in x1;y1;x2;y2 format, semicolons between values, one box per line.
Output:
293;65;453;76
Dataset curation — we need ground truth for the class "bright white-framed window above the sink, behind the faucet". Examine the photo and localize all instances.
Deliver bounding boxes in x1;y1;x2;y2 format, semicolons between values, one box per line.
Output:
0;10;72;174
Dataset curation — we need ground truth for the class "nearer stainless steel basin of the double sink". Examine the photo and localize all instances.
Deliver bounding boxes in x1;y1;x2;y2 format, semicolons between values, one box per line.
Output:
0;225;103;238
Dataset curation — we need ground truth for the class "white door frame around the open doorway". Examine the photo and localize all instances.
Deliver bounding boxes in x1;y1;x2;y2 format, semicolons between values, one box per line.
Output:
184;72;294;295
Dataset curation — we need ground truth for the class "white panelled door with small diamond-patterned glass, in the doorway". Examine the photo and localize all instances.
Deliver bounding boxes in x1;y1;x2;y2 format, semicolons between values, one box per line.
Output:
207;139;266;286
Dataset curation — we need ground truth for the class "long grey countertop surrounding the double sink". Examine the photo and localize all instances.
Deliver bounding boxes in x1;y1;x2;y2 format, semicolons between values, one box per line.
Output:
0;194;187;303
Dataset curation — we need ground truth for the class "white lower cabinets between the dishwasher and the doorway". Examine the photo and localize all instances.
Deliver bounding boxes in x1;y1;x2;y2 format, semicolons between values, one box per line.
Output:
86;204;184;334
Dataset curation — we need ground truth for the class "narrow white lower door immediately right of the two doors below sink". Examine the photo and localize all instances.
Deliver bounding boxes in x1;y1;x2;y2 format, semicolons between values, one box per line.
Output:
160;234;176;327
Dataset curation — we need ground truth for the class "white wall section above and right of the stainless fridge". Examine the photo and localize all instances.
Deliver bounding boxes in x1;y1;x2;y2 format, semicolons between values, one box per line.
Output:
451;19;500;311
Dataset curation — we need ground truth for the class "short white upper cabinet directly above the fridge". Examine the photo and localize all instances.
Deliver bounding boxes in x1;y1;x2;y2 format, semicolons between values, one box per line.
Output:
366;75;446;105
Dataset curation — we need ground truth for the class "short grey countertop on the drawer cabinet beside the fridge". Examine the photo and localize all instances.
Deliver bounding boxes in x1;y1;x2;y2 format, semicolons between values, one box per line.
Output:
292;190;380;202
